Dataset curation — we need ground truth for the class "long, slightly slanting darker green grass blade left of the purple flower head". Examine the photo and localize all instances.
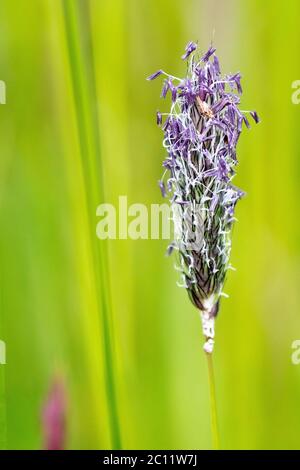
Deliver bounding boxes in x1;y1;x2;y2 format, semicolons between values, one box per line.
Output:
63;0;121;449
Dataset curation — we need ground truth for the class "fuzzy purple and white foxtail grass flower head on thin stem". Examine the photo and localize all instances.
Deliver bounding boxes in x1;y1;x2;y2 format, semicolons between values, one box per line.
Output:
148;42;259;353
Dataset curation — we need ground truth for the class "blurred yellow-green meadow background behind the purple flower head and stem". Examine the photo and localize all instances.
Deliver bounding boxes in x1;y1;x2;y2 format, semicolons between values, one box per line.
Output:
0;0;300;449
